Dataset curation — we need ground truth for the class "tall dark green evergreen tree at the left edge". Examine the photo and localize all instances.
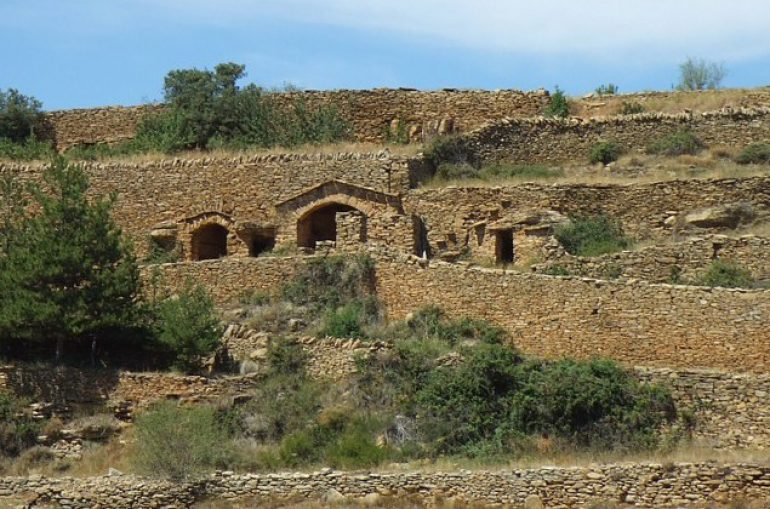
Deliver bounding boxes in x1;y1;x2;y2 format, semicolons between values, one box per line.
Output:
0;158;139;361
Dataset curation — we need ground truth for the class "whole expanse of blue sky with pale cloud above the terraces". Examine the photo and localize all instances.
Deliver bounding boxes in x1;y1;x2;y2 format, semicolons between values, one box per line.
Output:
0;0;770;109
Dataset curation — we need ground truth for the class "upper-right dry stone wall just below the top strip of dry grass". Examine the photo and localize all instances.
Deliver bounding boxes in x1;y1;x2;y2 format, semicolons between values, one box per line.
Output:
465;107;770;164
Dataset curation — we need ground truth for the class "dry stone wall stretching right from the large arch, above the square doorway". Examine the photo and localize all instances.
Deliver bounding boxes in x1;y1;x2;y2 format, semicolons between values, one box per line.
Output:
404;177;770;249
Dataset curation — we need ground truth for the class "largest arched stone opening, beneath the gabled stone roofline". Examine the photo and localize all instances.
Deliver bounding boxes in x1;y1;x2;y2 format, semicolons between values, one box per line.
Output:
296;195;371;249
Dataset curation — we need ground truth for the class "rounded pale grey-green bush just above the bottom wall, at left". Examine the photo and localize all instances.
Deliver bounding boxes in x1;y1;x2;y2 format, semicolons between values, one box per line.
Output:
132;402;233;480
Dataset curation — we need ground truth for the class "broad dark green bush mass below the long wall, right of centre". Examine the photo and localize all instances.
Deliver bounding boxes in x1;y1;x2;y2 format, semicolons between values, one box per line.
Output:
416;344;675;453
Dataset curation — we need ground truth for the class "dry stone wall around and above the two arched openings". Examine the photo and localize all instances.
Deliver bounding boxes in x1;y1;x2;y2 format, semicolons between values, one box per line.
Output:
0;153;421;256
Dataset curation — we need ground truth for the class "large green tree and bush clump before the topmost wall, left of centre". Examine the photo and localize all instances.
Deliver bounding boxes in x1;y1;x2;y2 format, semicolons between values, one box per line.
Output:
127;63;351;153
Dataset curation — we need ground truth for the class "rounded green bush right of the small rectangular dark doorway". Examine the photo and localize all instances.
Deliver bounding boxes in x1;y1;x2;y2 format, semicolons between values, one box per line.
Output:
555;215;631;256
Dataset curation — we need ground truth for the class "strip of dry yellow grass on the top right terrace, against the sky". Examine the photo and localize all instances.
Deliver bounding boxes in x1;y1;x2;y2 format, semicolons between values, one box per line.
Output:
571;88;770;117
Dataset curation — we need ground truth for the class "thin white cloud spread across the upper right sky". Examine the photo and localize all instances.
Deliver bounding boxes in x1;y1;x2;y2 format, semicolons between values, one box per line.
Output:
137;0;770;61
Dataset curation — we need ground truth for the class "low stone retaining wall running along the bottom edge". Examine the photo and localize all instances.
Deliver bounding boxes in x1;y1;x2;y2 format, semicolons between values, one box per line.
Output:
0;463;770;509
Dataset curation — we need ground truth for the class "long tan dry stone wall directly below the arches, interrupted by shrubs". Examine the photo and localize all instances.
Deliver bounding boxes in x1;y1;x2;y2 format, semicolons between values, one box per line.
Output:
145;253;770;372
